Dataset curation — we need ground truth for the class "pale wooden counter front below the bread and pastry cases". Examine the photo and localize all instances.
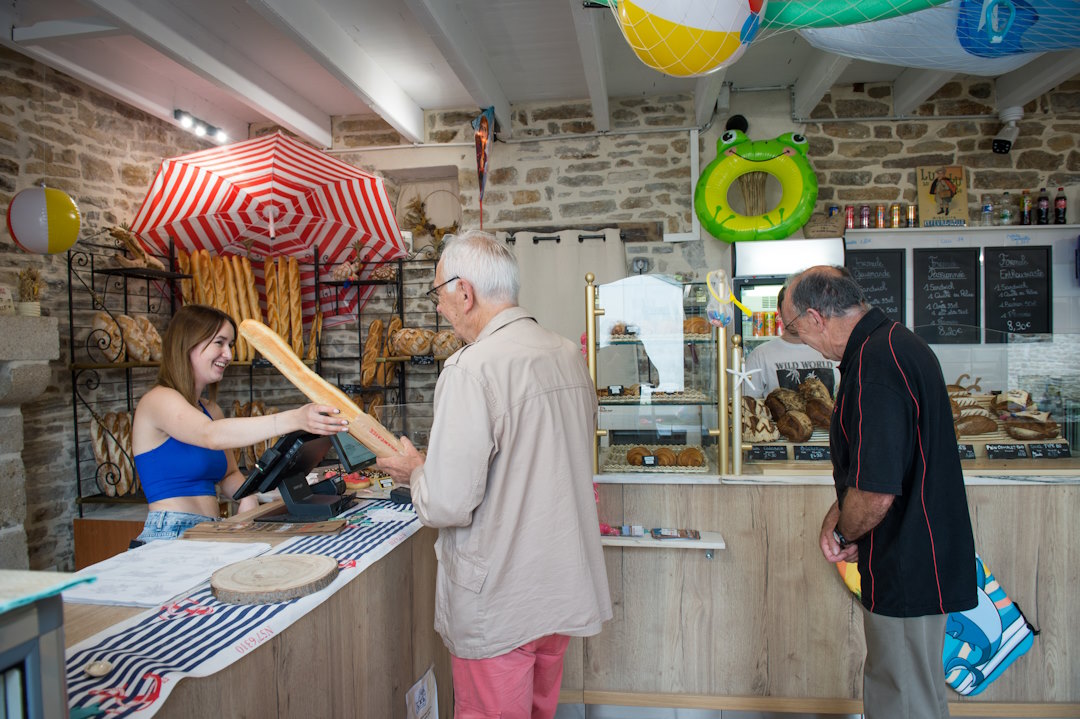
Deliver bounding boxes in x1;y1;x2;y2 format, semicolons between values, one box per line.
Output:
563;477;1080;717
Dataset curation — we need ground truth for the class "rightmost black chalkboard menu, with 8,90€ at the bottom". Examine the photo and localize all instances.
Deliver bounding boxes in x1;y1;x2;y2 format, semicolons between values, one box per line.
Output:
983;245;1052;342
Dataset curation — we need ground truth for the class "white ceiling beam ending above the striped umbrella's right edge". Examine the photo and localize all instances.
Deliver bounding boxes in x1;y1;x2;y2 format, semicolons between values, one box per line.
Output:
247;0;423;143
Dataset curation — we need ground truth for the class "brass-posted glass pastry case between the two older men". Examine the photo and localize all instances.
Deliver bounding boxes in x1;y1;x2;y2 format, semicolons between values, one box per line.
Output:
585;275;727;480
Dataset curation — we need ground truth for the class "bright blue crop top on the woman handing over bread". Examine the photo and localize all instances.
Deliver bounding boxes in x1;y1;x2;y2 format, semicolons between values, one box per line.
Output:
135;403;229;502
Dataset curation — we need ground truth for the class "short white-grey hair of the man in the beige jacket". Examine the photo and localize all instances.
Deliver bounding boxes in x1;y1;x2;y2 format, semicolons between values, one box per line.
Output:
438;230;522;304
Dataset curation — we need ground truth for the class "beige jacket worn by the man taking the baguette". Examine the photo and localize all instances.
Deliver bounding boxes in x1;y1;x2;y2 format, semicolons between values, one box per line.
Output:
410;308;611;659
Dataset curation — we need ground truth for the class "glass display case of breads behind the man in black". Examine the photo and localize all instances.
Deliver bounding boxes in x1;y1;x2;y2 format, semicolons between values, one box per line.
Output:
732;323;1080;472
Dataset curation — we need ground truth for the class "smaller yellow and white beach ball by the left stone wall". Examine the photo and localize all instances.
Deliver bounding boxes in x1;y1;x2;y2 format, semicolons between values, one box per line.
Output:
8;187;79;255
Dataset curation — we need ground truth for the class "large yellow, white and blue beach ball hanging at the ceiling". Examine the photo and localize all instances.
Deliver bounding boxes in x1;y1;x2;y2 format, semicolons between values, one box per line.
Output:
616;0;767;78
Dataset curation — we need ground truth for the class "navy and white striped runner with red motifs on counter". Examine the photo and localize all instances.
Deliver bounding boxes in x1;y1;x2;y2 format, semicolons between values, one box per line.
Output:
66;500;420;719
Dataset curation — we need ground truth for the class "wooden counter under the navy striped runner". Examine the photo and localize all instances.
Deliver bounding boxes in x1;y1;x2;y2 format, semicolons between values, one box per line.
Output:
64;520;453;719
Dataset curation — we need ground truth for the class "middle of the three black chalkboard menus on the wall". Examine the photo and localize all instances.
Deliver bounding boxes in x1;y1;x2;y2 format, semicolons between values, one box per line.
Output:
913;247;982;344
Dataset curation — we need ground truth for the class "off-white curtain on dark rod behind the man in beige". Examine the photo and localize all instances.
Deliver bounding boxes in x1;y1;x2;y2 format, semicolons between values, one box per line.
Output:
509;229;626;344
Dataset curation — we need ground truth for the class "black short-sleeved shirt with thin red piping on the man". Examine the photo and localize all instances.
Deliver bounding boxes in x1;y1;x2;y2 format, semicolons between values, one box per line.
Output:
829;309;976;616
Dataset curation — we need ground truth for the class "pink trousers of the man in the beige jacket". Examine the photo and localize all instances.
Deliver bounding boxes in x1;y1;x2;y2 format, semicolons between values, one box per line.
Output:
450;634;570;719
